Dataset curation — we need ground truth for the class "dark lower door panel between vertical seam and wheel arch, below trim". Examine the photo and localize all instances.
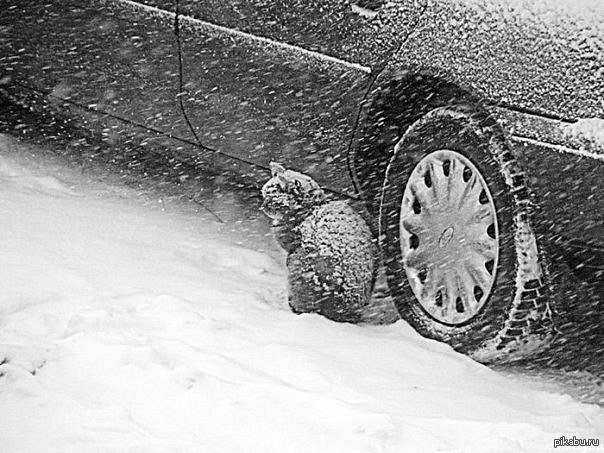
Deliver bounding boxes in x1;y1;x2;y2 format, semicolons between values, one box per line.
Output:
175;14;368;190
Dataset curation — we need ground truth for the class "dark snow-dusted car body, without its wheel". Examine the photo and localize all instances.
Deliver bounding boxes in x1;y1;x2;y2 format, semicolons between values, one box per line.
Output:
0;0;604;360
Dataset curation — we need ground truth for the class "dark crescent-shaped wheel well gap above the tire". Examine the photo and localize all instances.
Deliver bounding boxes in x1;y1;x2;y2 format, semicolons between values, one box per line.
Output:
350;72;480;218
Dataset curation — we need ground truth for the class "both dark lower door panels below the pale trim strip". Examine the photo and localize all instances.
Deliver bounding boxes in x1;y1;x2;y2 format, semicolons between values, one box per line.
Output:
2;1;368;189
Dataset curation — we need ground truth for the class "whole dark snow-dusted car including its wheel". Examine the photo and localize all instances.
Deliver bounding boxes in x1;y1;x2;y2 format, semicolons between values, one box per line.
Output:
0;0;604;362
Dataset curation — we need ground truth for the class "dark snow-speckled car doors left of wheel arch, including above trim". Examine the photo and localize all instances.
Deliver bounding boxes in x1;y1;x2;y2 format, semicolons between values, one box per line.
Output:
0;0;419;195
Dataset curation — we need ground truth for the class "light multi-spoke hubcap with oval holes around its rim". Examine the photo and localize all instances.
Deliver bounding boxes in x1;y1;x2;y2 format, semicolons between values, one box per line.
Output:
400;150;499;325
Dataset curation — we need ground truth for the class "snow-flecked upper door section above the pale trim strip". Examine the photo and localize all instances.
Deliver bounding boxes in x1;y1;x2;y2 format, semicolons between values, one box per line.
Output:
137;0;425;66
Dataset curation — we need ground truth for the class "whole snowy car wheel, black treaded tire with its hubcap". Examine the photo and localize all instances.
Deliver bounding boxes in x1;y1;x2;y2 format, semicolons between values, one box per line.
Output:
379;106;555;362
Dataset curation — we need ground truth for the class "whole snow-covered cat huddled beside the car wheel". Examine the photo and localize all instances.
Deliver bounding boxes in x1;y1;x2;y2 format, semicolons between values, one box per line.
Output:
262;163;377;322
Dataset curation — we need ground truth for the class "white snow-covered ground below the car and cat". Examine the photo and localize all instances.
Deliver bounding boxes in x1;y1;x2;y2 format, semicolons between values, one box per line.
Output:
0;136;604;452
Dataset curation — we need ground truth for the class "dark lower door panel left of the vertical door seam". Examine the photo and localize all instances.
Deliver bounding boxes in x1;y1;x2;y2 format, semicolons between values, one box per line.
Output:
0;0;193;143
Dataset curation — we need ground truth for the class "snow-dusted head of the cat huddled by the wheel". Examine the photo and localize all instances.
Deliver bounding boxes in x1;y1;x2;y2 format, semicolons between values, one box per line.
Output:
262;162;325;225
